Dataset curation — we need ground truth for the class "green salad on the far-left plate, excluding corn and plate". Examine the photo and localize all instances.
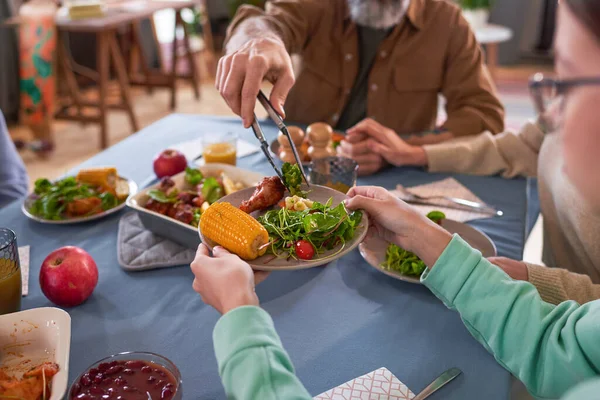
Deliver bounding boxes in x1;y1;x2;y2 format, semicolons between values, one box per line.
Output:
29;177;122;221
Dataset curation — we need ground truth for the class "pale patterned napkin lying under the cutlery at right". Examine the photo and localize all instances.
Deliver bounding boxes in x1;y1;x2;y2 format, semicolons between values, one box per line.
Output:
391;178;494;222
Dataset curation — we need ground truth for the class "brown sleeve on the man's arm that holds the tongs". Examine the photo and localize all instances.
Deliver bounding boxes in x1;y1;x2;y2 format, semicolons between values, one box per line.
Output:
227;0;323;54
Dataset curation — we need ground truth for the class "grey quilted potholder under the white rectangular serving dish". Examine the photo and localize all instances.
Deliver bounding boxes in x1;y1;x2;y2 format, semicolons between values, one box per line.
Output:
117;212;196;271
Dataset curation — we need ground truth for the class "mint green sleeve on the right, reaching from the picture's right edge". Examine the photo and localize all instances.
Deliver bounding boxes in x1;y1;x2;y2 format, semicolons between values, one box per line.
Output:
421;235;600;398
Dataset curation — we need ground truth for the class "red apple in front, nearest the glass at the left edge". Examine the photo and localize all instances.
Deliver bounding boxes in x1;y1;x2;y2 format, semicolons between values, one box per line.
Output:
40;246;98;307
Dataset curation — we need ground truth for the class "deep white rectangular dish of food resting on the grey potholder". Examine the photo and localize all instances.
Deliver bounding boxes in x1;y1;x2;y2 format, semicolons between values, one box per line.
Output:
127;163;264;248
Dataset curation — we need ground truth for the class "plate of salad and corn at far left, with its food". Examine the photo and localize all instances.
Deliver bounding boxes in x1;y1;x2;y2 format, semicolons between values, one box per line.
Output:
21;167;137;224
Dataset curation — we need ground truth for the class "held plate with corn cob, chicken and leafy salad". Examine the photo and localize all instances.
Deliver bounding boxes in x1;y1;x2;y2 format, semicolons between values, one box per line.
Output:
199;163;369;271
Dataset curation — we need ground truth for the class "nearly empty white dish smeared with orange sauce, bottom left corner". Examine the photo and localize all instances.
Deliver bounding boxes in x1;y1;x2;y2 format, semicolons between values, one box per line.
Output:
0;307;71;400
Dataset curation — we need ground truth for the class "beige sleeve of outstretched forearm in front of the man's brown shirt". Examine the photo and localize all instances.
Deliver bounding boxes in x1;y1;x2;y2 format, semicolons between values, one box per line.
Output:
423;123;544;178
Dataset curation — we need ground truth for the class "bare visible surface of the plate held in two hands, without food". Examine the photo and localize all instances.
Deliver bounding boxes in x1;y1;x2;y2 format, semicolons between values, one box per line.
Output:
198;185;369;271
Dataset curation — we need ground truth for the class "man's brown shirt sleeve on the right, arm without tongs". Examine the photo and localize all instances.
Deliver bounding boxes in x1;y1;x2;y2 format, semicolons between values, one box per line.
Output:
442;12;504;136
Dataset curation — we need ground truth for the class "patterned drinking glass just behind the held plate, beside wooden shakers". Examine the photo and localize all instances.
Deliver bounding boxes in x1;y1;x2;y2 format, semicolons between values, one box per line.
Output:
309;157;358;193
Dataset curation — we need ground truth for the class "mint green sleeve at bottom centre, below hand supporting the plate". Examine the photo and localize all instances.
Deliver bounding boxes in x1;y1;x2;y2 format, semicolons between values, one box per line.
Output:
213;306;311;400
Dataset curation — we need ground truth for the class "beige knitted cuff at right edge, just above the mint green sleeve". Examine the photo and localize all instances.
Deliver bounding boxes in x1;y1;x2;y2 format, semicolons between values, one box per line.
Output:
527;264;600;304
